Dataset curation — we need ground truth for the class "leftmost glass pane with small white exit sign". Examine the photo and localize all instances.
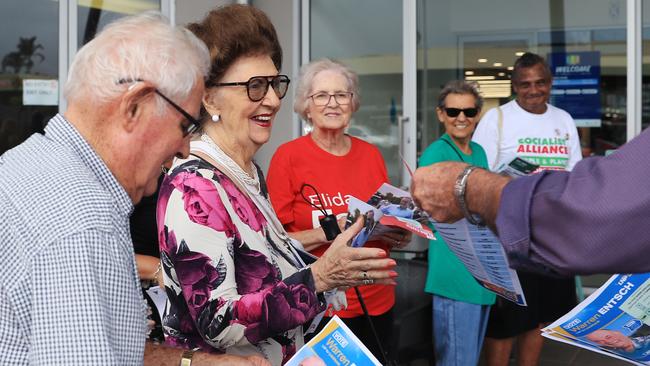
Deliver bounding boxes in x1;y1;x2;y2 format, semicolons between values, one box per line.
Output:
0;0;59;154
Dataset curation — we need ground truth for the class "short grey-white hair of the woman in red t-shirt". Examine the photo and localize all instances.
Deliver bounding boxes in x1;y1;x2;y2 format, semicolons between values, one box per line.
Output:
293;58;361;124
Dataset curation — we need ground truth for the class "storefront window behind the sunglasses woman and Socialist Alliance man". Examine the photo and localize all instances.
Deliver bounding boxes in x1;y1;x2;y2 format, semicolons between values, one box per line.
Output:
418;0;627;156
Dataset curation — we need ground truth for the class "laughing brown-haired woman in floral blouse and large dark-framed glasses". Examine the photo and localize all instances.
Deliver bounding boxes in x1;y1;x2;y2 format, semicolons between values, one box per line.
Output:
157;5;397;365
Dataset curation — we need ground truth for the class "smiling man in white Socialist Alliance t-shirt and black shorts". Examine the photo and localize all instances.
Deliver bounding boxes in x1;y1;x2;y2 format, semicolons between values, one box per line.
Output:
472;53;582;366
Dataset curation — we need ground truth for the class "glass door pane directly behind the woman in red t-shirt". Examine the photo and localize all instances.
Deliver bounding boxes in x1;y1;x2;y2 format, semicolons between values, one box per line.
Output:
308;0;414;185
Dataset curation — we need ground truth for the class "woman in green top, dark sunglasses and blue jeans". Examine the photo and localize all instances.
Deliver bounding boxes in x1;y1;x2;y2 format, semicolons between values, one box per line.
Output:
419;81;495;365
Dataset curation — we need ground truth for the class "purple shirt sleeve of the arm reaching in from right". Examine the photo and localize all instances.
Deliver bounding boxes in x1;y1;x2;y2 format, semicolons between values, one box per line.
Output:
496;125;650;274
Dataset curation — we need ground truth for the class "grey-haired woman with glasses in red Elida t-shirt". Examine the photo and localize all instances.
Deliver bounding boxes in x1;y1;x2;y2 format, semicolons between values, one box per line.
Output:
267;59;410;360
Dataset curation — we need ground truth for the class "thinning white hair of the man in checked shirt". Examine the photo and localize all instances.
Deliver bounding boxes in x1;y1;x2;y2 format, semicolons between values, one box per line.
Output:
64;12;210;113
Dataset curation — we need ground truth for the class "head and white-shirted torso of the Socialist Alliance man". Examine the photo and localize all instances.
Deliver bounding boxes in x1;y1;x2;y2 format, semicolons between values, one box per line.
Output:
473;53;582;171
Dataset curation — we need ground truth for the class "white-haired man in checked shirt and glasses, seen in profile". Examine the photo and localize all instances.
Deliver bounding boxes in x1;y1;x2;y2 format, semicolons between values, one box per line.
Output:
0;13;265;366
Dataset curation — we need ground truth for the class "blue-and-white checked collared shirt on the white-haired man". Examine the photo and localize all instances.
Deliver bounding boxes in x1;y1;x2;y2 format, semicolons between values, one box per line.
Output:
0;115;146;365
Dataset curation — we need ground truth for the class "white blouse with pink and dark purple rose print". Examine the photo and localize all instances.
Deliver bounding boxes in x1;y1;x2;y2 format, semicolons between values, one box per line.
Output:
157;157;325;365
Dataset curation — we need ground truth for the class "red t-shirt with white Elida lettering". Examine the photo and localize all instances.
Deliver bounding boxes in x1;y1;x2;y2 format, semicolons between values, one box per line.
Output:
267;135;395;318
